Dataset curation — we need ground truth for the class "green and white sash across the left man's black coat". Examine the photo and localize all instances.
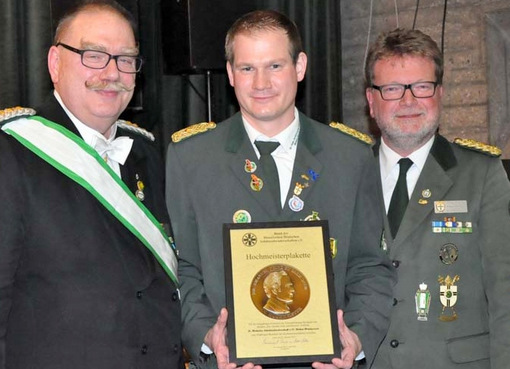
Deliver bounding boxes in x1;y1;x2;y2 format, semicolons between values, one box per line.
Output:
2;116;178;284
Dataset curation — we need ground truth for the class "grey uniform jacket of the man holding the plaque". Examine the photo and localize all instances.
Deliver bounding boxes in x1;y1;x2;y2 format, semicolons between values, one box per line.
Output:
166;113;393;362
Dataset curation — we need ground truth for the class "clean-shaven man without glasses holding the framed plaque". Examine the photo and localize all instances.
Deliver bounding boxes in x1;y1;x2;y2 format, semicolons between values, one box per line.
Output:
166;11;394;368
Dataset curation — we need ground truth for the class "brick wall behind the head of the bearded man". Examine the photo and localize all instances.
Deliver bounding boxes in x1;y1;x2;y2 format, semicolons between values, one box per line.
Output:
341;0;510;158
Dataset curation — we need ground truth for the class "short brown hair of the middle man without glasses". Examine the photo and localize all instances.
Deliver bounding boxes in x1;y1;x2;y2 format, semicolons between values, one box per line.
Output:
225;10;303;64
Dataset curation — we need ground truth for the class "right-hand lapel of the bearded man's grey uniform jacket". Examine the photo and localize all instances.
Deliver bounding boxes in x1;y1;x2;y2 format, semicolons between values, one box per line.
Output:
377;135;457;250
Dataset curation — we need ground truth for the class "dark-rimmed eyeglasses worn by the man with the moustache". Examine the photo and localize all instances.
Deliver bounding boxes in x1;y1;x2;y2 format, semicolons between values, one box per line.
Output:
55;42;143;73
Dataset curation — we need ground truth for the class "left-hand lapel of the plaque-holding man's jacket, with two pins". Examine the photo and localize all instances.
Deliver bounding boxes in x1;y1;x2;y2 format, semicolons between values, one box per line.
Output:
225;113;280;219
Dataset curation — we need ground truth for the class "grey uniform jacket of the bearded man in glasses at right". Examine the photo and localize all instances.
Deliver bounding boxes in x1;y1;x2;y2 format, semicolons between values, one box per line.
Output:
374;135;510;369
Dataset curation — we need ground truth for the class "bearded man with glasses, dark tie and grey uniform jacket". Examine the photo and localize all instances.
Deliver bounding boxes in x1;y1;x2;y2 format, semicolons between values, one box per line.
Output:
365;29;510;369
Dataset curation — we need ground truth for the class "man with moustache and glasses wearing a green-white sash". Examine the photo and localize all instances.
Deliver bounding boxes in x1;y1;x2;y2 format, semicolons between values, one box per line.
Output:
0;0;182;369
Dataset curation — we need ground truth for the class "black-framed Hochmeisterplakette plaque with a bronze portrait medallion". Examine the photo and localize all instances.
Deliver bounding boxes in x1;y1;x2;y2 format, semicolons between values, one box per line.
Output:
223;221;340;365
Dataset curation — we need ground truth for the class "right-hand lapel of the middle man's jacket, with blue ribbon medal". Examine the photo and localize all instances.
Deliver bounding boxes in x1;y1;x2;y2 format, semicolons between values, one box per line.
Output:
281;113;323;219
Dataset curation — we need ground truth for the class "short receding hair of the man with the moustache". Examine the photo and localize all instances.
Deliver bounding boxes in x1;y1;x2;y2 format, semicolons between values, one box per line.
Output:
53;0;138;45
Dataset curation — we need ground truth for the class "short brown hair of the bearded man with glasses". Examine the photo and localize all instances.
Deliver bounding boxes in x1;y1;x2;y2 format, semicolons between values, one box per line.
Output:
365;28;444;87
